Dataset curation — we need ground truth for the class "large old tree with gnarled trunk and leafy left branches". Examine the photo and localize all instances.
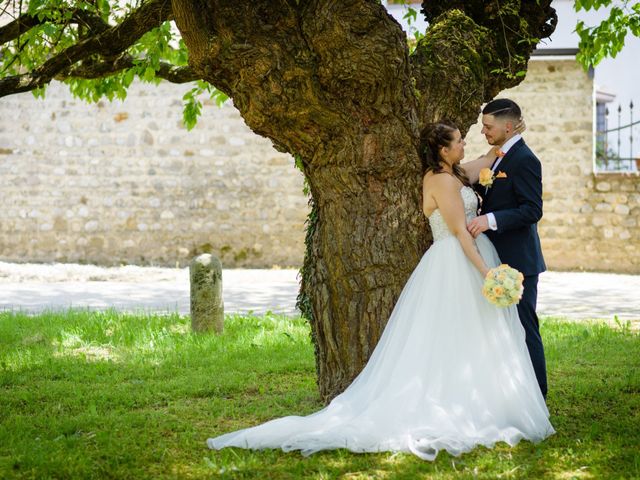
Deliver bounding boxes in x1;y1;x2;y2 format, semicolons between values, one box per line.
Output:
0;0;557;400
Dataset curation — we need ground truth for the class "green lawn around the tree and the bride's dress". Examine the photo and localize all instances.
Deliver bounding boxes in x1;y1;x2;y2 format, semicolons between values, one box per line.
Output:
0;311;640;479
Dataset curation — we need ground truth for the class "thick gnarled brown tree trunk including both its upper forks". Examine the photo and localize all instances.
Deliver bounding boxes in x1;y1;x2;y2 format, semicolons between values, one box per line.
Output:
172;0;553;401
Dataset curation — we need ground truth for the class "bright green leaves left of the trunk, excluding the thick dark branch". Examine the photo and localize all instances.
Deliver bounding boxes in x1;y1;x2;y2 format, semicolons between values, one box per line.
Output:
0;0;227;129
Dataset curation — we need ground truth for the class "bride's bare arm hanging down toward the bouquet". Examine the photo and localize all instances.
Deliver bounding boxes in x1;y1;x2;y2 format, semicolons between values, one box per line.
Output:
433;175;489;277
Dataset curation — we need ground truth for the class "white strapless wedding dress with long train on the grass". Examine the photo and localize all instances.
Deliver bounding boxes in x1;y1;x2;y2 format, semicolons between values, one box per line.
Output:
207;187;554;460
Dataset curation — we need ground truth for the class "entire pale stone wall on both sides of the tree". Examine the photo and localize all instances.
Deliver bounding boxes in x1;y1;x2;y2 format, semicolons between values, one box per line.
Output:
0;59;640;273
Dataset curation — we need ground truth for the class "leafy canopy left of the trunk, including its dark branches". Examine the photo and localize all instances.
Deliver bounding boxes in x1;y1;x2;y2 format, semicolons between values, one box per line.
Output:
0;0;227;129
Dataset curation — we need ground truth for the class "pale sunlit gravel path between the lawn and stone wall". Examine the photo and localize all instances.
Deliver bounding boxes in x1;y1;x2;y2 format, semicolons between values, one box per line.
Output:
0;262;640;325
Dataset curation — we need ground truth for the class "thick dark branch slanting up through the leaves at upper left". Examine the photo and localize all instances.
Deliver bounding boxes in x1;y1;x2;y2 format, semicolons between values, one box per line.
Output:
0;0;172;97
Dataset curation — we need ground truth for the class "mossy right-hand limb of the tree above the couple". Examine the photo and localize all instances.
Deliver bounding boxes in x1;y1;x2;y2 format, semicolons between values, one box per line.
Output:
411;0;557;133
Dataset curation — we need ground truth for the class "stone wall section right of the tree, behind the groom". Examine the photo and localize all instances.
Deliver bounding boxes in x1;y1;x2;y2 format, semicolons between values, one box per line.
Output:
467;59;640;273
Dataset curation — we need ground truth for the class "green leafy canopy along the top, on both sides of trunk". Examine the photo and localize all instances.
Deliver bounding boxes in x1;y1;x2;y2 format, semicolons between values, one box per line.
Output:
0;0;640;129
